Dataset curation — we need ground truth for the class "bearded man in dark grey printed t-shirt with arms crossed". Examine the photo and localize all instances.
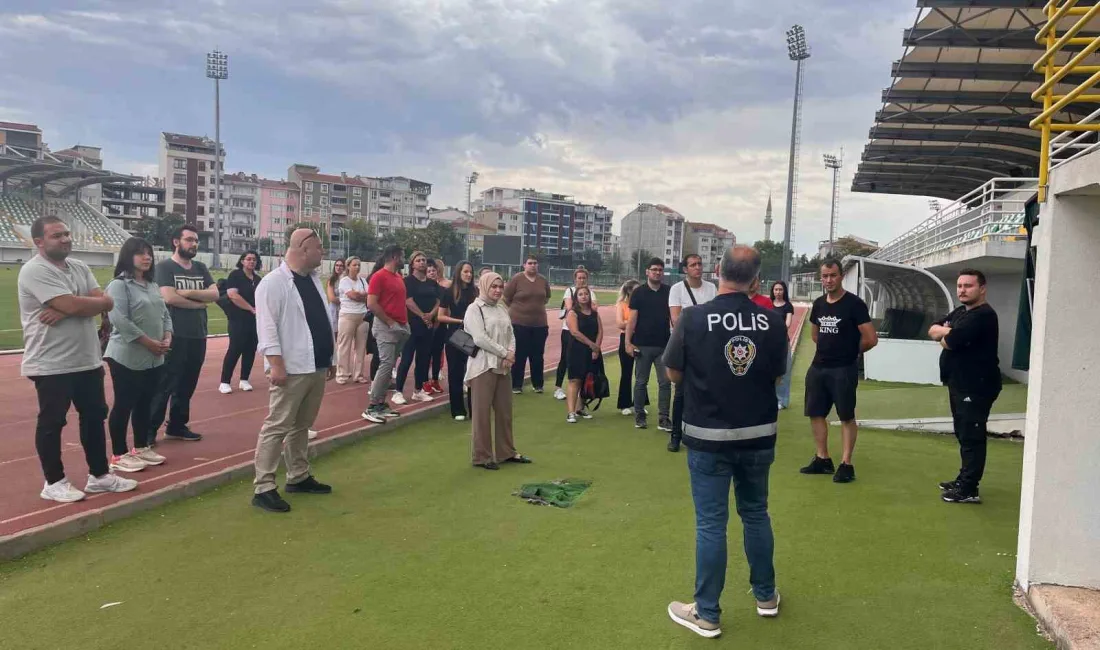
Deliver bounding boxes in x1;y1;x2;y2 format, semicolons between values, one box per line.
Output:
150;224;218;444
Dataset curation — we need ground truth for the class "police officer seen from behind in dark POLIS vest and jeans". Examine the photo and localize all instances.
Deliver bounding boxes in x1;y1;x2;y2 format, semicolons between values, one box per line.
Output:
664;245;787;637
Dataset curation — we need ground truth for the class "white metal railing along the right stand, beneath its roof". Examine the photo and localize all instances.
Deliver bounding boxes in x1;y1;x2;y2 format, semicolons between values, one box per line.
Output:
871;178;1038;264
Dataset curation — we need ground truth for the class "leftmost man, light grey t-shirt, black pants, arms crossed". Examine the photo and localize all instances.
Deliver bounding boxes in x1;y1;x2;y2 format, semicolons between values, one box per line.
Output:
19;217;138;503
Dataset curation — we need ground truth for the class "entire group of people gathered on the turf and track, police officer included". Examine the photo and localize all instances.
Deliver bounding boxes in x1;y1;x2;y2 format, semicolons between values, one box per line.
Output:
12;217;1001;637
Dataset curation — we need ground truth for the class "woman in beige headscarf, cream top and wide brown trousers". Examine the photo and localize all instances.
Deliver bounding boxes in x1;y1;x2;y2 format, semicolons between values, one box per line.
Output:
462;273;531;470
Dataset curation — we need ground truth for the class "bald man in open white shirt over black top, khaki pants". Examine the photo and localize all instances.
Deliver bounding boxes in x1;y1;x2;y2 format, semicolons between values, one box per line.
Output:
252;228;336;513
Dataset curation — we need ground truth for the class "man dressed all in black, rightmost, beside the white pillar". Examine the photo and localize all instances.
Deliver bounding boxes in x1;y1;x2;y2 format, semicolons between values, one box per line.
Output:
928;268;1001;504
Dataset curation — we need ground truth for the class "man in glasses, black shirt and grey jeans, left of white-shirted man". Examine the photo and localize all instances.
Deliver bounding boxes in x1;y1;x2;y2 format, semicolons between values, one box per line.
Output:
625;257;672;432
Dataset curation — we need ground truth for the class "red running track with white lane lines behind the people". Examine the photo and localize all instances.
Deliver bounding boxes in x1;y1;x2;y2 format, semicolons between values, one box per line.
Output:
0;307;805;538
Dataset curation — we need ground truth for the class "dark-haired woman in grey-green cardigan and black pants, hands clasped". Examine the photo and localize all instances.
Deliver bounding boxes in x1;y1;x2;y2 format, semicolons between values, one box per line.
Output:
103;238;172;472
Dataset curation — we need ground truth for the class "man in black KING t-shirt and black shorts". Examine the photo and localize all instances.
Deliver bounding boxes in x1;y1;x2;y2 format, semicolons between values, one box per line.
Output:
800;260;879;483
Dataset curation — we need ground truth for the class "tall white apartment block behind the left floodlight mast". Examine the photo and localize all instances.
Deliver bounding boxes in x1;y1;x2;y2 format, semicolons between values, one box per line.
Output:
158;132;226;246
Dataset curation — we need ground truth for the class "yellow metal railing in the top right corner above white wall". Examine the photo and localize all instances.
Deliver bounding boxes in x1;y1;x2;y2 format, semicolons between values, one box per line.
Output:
1030;0;1100;201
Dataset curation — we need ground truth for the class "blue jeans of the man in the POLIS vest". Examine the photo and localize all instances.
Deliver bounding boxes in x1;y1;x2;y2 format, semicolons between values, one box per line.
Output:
688;449;776;623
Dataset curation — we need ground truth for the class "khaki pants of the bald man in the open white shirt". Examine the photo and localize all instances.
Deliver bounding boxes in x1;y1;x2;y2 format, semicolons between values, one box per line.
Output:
252;368;328;494
